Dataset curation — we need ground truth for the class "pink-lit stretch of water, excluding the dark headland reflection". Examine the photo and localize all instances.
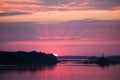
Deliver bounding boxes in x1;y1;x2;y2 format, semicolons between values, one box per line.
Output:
34;64;120;80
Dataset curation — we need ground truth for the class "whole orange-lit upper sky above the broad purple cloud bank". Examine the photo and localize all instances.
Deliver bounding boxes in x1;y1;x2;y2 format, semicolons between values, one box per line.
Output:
0;0;120;23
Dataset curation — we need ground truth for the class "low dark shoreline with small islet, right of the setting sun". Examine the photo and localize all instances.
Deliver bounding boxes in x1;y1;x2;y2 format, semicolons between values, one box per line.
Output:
58;55;120;67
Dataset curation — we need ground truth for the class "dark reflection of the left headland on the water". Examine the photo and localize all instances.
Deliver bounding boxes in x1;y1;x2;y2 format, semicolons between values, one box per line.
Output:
0;65;56;72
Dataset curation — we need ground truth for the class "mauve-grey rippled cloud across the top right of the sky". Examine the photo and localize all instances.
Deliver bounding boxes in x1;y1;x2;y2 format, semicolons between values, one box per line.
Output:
42;0;120;10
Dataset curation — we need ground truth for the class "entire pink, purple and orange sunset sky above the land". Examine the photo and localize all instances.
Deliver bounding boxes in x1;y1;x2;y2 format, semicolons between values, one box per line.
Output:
0;0;120;56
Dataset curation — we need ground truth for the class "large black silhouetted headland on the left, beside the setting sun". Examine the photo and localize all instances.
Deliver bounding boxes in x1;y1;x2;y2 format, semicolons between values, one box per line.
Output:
0;51;58;66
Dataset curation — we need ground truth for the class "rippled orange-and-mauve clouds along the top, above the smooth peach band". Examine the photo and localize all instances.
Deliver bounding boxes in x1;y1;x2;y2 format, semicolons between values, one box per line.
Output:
0;0;120;12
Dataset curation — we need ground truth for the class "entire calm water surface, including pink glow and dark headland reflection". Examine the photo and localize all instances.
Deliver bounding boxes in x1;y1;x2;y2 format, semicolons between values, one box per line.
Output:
0;62;120;80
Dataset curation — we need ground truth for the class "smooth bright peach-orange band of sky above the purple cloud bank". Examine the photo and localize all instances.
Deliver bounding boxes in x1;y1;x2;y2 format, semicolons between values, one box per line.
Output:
0;10;120;23
